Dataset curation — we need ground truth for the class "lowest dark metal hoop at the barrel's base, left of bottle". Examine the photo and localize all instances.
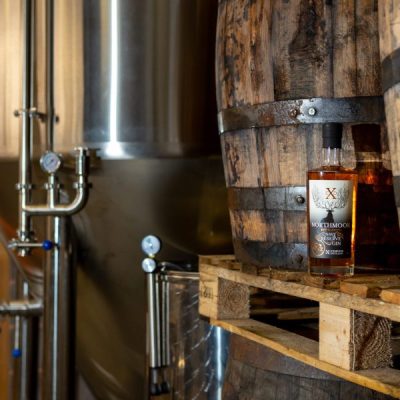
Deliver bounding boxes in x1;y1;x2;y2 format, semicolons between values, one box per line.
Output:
233;238;307;270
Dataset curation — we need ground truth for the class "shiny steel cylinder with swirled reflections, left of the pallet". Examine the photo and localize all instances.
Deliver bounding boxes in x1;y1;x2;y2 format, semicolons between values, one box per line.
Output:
166;273;229;400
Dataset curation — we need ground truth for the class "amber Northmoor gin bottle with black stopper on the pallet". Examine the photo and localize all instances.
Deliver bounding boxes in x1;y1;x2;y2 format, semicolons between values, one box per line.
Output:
307;123;358;278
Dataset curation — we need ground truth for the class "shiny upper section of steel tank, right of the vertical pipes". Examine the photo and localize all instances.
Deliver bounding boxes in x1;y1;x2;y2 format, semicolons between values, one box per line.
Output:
54;0;218;159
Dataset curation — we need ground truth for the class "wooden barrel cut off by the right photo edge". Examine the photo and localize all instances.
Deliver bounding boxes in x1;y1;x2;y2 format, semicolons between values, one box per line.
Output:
379;0;400;230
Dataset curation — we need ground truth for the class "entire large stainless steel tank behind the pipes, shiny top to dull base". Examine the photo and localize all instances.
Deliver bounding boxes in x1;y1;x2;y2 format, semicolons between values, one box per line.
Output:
0;0;231;400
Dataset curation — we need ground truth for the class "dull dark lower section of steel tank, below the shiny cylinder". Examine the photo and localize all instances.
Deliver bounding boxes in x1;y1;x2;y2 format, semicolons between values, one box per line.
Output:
73;157;232;400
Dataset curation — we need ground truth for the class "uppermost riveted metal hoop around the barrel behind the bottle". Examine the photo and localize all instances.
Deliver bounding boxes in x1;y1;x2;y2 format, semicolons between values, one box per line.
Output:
218;96;385;134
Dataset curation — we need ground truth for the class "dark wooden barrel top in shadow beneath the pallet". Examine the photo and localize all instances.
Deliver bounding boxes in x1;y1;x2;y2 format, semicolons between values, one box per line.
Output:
222;335;393;400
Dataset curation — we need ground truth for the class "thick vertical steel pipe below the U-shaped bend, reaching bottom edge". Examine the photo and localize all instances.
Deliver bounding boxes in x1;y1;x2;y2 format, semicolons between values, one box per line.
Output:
43;217;75;400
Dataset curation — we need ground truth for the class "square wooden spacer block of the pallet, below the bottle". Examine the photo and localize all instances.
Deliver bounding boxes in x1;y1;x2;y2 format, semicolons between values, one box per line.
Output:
319;303;392;370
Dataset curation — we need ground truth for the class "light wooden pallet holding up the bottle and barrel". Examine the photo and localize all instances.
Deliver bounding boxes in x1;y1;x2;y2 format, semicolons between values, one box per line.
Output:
199;256;400;398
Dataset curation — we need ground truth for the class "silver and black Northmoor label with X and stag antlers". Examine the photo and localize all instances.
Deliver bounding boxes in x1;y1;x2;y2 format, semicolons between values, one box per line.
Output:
308;180;353;258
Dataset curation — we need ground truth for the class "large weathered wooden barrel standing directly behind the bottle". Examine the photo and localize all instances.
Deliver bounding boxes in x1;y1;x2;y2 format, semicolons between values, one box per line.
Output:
216;0;400;269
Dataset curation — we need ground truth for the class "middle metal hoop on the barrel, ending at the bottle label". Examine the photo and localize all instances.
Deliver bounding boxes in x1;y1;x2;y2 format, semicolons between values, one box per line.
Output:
228;186;307;211
